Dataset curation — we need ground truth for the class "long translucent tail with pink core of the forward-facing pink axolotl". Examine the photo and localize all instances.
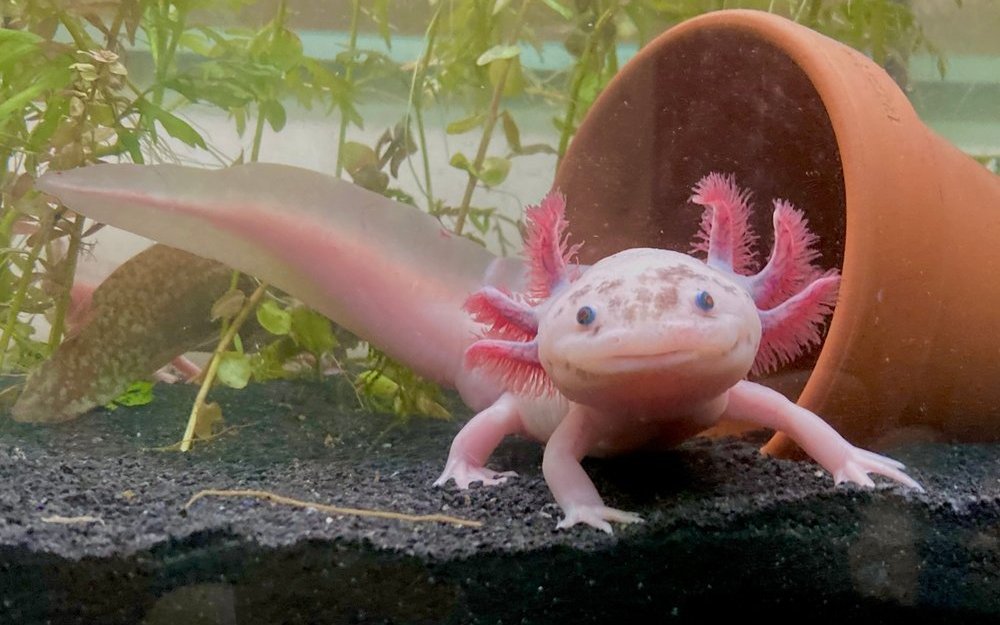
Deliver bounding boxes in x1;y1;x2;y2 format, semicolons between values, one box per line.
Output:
37;163;525;403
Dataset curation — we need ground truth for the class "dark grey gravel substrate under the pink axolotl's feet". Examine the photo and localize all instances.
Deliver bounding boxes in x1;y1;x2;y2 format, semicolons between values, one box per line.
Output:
0;383;1000;625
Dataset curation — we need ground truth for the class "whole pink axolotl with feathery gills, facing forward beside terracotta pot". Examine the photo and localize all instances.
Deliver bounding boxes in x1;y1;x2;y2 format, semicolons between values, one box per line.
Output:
38;164;919;531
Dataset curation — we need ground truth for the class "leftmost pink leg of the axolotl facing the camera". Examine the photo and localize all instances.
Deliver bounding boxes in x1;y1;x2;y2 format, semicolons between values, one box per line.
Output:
434;393;524;489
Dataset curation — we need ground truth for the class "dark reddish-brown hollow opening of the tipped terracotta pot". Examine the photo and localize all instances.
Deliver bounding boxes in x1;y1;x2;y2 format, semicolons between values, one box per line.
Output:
556;27;846;396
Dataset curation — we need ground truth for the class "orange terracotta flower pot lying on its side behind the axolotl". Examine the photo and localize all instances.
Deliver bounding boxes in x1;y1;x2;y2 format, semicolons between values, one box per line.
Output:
555;10;1000;453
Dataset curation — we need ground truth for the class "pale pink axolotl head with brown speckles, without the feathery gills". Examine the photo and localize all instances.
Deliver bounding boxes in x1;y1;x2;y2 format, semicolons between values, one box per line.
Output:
537;248;761;409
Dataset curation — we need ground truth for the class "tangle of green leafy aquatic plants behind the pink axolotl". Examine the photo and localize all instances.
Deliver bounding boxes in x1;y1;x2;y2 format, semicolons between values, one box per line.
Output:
0;0;968;445
